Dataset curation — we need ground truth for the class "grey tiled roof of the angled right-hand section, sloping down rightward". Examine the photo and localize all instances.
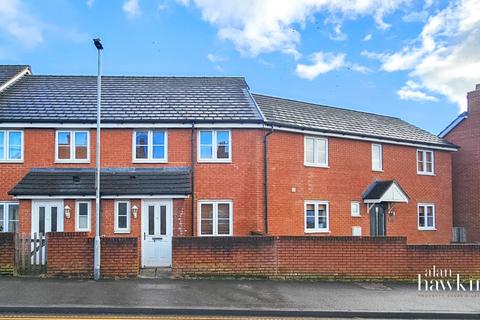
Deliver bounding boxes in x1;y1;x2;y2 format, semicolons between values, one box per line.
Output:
253;94;455;147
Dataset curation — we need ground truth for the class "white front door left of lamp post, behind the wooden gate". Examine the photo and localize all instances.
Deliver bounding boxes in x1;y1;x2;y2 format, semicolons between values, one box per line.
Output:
32;200;63;236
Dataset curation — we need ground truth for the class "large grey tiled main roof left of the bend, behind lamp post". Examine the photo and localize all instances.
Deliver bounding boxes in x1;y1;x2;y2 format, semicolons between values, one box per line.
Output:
0;75;262;123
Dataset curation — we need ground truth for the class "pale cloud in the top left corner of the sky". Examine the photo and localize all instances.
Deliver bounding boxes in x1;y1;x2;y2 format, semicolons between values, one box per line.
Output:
0;0;43;47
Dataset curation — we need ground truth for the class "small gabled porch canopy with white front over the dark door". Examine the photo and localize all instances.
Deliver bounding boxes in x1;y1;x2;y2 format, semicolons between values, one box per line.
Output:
363;180;408;204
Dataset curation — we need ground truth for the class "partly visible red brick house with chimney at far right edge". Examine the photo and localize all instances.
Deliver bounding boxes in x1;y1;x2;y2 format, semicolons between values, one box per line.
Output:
440;84;480;242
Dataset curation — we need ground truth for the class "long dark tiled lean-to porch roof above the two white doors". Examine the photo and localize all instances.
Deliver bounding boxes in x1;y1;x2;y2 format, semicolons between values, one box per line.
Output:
9;167;191;196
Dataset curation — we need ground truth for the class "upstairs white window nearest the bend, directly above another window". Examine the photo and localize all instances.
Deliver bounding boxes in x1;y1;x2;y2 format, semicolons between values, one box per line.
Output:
198;130;232;162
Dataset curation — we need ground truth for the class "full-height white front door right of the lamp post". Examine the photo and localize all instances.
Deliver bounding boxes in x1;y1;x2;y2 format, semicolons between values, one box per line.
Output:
142;200;172;267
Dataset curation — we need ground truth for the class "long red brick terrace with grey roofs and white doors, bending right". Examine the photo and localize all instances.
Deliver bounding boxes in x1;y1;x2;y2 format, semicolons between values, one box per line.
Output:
0;66;457;266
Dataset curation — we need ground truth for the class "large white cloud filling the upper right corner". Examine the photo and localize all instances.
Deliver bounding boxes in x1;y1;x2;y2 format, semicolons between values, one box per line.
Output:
362;0;480;110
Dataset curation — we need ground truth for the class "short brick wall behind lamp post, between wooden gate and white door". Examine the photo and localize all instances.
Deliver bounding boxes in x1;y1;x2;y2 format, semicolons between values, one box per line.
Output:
47;232;139;278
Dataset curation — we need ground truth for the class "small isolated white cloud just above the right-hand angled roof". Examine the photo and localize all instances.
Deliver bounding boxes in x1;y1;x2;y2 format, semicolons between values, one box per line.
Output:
295;51;345;80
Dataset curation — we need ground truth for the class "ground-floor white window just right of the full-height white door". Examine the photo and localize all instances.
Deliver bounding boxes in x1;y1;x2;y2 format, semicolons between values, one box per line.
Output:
198;200;233;236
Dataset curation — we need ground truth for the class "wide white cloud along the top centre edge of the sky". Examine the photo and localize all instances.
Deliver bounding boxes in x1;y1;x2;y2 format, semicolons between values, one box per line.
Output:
177;0;409;59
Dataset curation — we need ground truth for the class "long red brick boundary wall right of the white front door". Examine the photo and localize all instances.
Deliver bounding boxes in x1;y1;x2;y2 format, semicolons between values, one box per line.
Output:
173;236;480;280
